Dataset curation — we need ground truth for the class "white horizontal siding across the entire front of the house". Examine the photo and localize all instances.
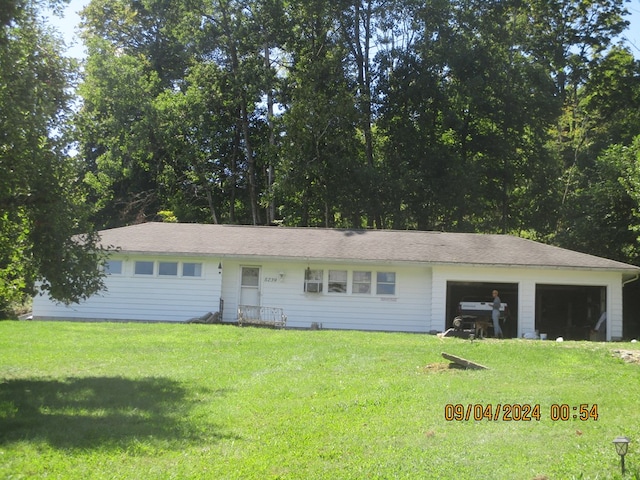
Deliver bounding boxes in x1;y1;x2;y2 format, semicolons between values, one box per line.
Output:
33;253;622;339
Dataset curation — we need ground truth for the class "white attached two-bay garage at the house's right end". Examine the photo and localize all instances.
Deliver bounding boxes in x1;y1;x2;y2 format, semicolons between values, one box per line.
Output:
432;260;637;340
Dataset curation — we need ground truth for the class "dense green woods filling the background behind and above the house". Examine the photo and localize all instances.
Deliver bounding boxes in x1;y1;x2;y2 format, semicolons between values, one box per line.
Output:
5;0;640;314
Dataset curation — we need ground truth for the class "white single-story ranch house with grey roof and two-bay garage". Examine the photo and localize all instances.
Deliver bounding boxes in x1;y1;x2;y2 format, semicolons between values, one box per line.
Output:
33;223;640;340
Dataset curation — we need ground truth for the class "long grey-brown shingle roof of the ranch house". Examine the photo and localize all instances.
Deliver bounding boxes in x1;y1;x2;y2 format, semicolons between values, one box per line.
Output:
100;223;640;273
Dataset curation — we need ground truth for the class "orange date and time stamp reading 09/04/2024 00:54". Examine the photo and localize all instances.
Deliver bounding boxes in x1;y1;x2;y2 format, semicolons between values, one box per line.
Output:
444;403;598;422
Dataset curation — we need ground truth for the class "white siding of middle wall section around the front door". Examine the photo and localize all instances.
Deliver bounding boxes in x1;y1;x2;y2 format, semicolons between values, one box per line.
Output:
222;259;431;332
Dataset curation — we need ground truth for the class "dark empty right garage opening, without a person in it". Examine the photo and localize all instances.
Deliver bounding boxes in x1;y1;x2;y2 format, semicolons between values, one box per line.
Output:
536;285;607;341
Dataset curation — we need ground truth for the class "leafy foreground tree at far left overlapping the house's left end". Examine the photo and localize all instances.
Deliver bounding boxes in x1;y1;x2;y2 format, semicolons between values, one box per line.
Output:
0;0;107;315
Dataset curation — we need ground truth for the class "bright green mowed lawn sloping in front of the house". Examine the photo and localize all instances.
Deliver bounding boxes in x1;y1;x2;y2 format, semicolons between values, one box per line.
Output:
0;322;640;479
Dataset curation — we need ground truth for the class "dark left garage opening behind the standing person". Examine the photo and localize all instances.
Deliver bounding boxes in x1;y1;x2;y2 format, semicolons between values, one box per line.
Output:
446;282;518;338
